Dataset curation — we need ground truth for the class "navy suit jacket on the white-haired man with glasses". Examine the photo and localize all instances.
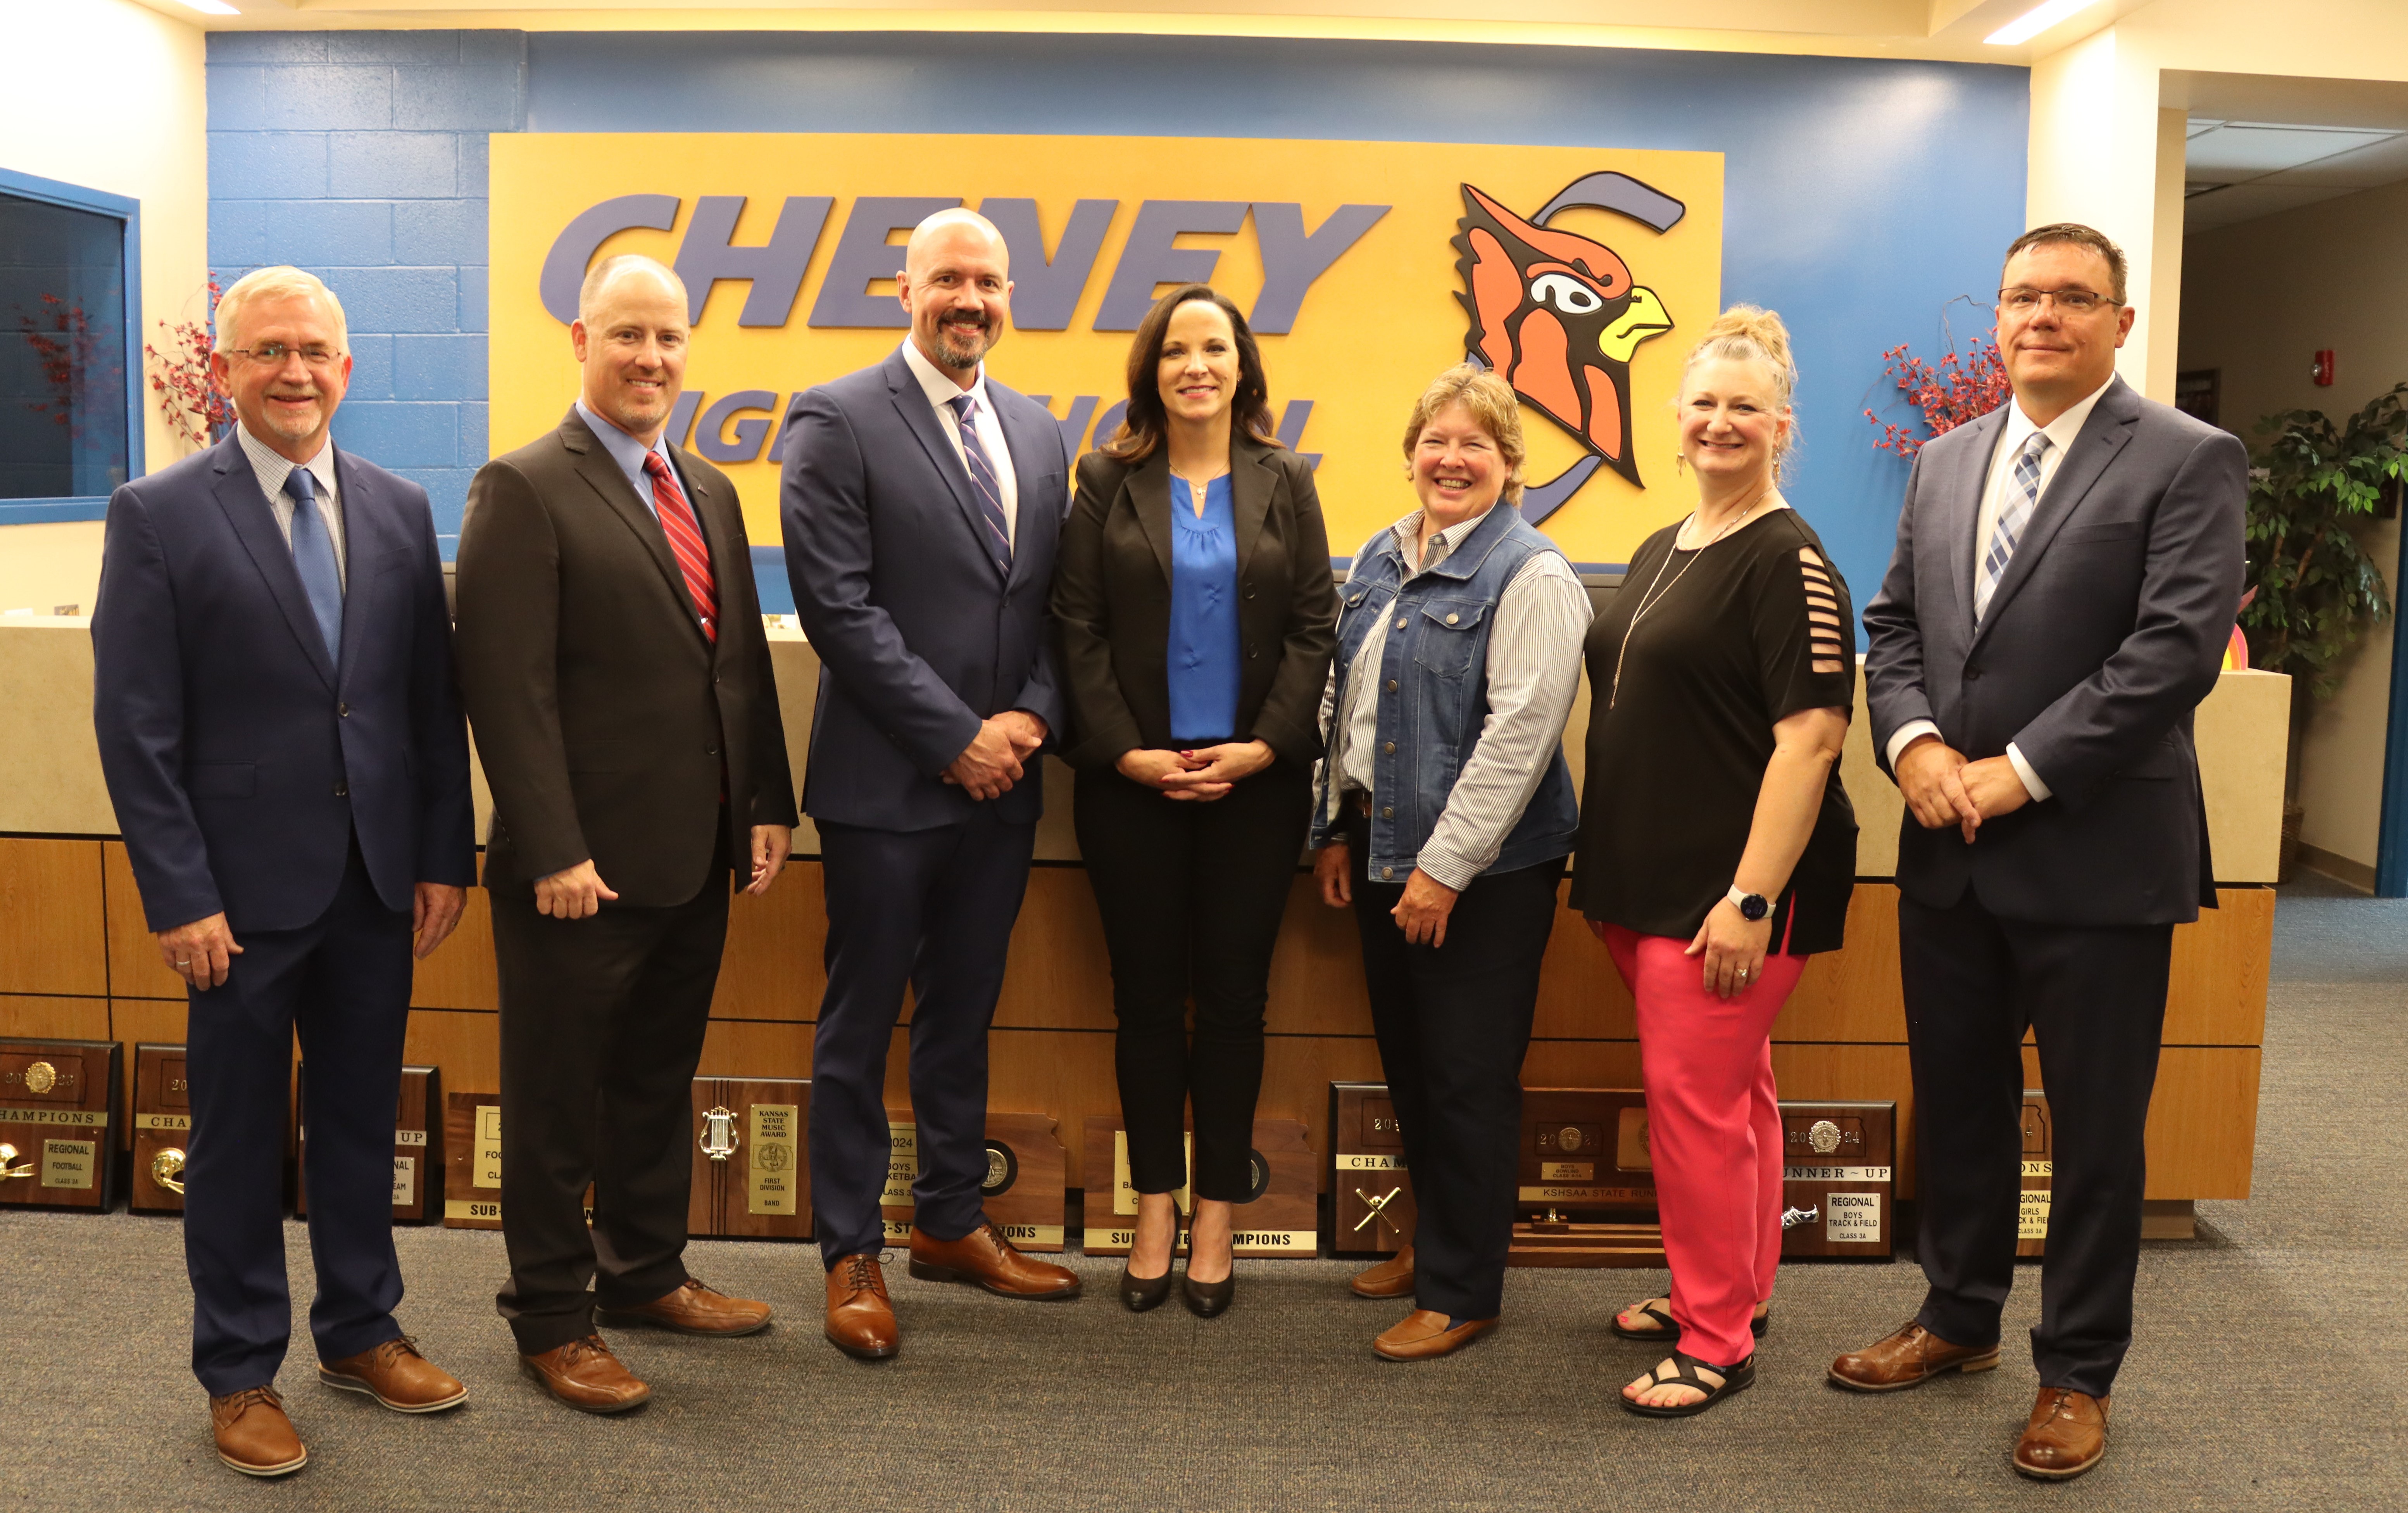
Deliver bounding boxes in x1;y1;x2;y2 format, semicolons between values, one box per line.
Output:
91;436;477;937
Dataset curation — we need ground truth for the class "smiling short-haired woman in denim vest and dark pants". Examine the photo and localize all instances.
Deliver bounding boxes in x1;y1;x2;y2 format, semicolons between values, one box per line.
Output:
1313;364;1589;1361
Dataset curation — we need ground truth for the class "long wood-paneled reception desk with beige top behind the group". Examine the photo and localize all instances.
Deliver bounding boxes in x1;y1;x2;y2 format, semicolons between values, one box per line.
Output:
0;617;2290;1209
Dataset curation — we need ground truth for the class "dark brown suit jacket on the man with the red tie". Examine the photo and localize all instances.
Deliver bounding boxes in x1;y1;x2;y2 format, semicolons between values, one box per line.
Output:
453;407;795;908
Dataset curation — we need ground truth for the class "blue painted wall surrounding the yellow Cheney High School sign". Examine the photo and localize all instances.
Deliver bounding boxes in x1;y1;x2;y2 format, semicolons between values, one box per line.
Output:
209;31;2030;614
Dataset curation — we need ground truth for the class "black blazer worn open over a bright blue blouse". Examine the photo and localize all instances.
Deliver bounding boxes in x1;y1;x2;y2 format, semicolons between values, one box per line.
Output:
1052;436;1339;769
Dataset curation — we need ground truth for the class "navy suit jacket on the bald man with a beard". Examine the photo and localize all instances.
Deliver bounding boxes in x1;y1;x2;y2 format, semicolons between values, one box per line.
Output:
780;349;1069;831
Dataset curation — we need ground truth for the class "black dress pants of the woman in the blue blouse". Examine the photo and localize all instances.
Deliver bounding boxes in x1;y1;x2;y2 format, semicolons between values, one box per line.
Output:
1074;761;1313;1202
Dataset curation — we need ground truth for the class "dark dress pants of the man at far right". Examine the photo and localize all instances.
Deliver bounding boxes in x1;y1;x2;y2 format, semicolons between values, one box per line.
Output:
1897;889;2174;1397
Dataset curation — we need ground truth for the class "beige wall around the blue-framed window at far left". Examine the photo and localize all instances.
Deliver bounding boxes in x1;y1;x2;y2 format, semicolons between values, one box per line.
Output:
0;0;209;610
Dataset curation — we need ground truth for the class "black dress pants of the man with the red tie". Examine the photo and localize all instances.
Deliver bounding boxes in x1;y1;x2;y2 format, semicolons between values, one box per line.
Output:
496;843;730;1356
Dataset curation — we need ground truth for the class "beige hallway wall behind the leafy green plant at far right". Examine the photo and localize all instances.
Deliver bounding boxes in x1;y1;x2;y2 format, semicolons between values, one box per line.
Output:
2182;183;2408;867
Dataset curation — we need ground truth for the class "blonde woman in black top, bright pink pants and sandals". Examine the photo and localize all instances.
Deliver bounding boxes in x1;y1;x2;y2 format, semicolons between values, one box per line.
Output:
1572;306;1856;1416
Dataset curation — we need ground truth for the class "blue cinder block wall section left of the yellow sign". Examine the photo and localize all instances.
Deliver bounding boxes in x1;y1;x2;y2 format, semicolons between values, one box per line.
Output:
209;31;527;544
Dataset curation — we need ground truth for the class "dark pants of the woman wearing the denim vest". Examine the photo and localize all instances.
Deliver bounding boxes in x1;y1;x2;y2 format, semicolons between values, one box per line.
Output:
1349;824;1563;1318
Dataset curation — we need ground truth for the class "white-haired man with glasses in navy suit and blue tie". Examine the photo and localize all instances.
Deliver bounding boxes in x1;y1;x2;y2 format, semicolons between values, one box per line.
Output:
91;268;474;1477
